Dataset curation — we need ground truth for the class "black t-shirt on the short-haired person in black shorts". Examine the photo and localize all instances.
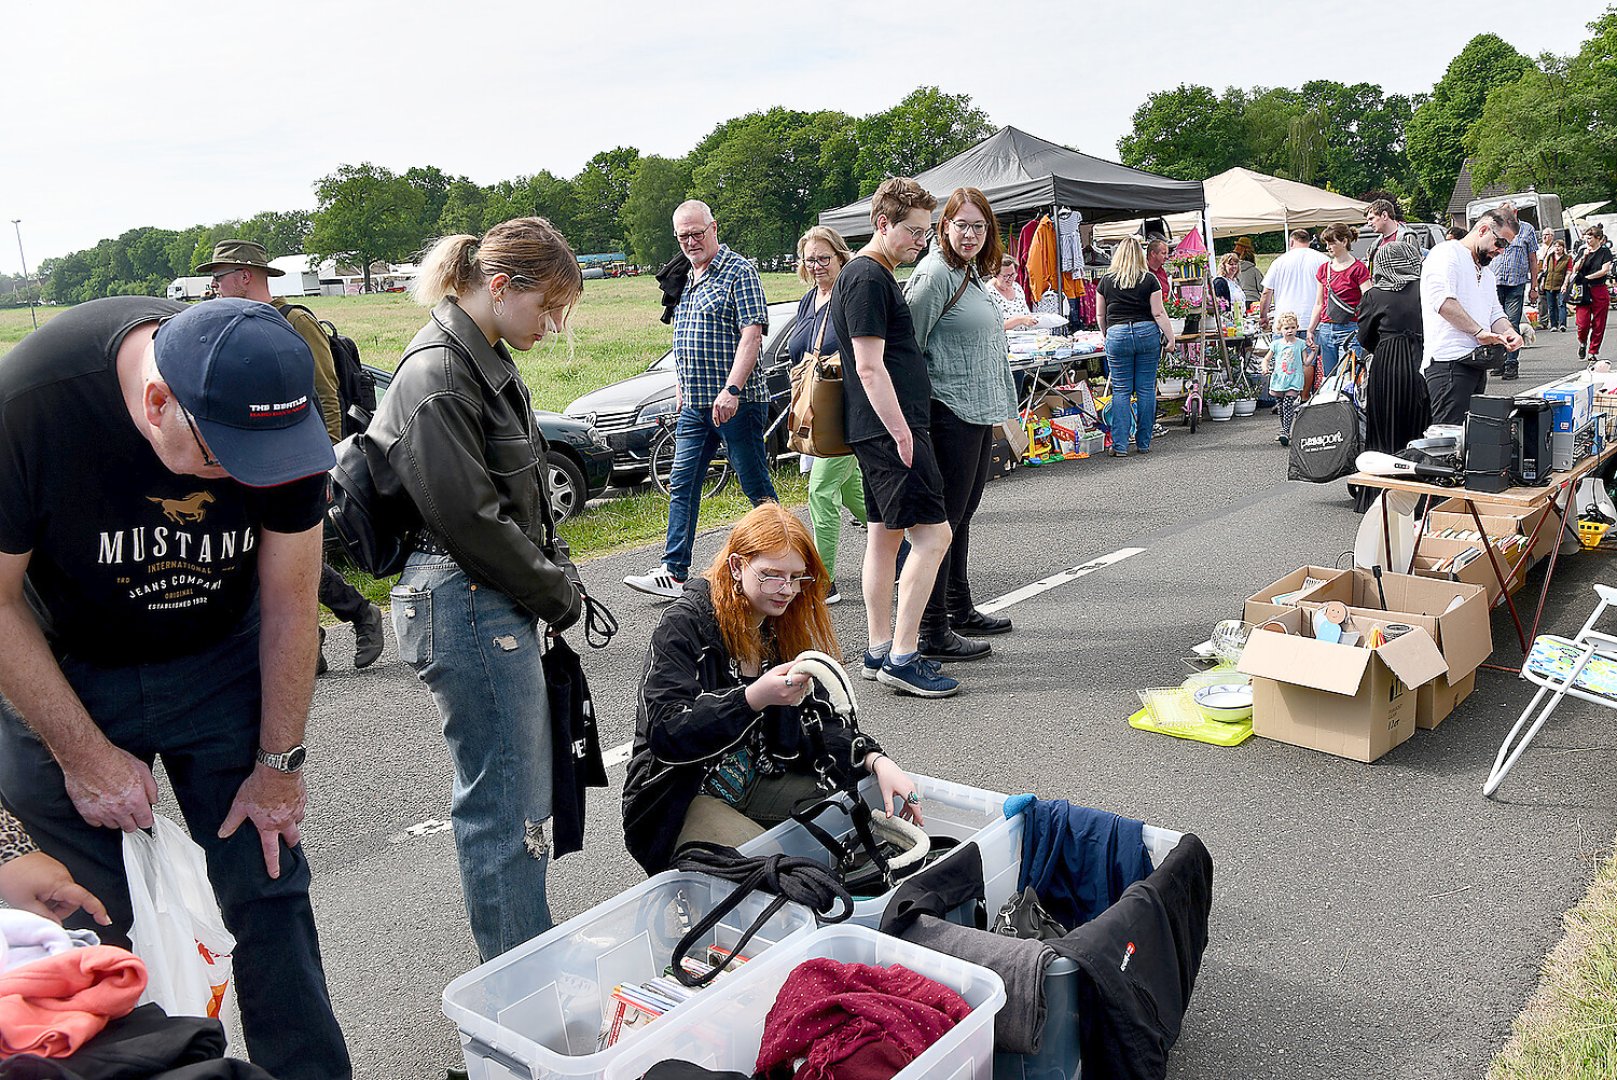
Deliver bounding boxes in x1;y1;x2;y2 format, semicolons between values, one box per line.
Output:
831;255;931;443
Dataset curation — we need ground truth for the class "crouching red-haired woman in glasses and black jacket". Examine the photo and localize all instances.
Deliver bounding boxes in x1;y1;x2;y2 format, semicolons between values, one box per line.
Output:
623;503;923;873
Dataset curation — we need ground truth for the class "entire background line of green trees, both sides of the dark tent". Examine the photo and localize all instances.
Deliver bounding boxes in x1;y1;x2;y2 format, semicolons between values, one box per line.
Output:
31;8;1617;302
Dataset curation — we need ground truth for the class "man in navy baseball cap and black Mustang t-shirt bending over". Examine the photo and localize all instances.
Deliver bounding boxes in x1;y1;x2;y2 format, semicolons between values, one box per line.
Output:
0;296;351;1080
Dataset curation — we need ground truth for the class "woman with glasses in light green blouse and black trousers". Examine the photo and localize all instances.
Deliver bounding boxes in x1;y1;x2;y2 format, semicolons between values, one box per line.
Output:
904;188;1015;661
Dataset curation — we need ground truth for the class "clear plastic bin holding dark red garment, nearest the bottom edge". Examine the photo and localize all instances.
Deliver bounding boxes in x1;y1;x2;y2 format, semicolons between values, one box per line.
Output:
606;923;1006;1080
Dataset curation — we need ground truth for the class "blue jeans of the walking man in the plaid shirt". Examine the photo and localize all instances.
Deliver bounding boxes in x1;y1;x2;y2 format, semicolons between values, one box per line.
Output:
663;401;776;579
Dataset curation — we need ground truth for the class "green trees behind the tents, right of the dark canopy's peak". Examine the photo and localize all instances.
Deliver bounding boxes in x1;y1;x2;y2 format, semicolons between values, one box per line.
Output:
1117;8;1617;220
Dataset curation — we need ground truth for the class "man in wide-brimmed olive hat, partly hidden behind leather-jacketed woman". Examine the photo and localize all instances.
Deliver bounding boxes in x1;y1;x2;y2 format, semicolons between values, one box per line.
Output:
197;239;383;674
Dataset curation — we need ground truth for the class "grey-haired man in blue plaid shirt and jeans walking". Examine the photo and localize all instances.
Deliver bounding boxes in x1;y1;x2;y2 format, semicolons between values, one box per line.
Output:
623;199;776;600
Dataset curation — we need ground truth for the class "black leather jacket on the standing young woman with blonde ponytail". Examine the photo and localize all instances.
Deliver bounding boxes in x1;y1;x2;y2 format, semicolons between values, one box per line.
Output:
365;297;584;631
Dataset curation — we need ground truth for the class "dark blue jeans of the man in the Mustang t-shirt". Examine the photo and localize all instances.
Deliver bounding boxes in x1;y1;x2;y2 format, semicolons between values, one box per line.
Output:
0;614;353;1080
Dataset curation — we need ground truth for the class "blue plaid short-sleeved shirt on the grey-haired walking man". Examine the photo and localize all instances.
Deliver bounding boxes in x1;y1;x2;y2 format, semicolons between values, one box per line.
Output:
674;244;770;409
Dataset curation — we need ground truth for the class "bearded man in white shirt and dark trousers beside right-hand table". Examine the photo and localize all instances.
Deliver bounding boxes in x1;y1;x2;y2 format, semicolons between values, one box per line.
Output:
1420;209;1522;424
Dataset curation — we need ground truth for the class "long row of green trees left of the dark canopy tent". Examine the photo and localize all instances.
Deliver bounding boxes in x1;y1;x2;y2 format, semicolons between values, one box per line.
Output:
31;87;991;302
